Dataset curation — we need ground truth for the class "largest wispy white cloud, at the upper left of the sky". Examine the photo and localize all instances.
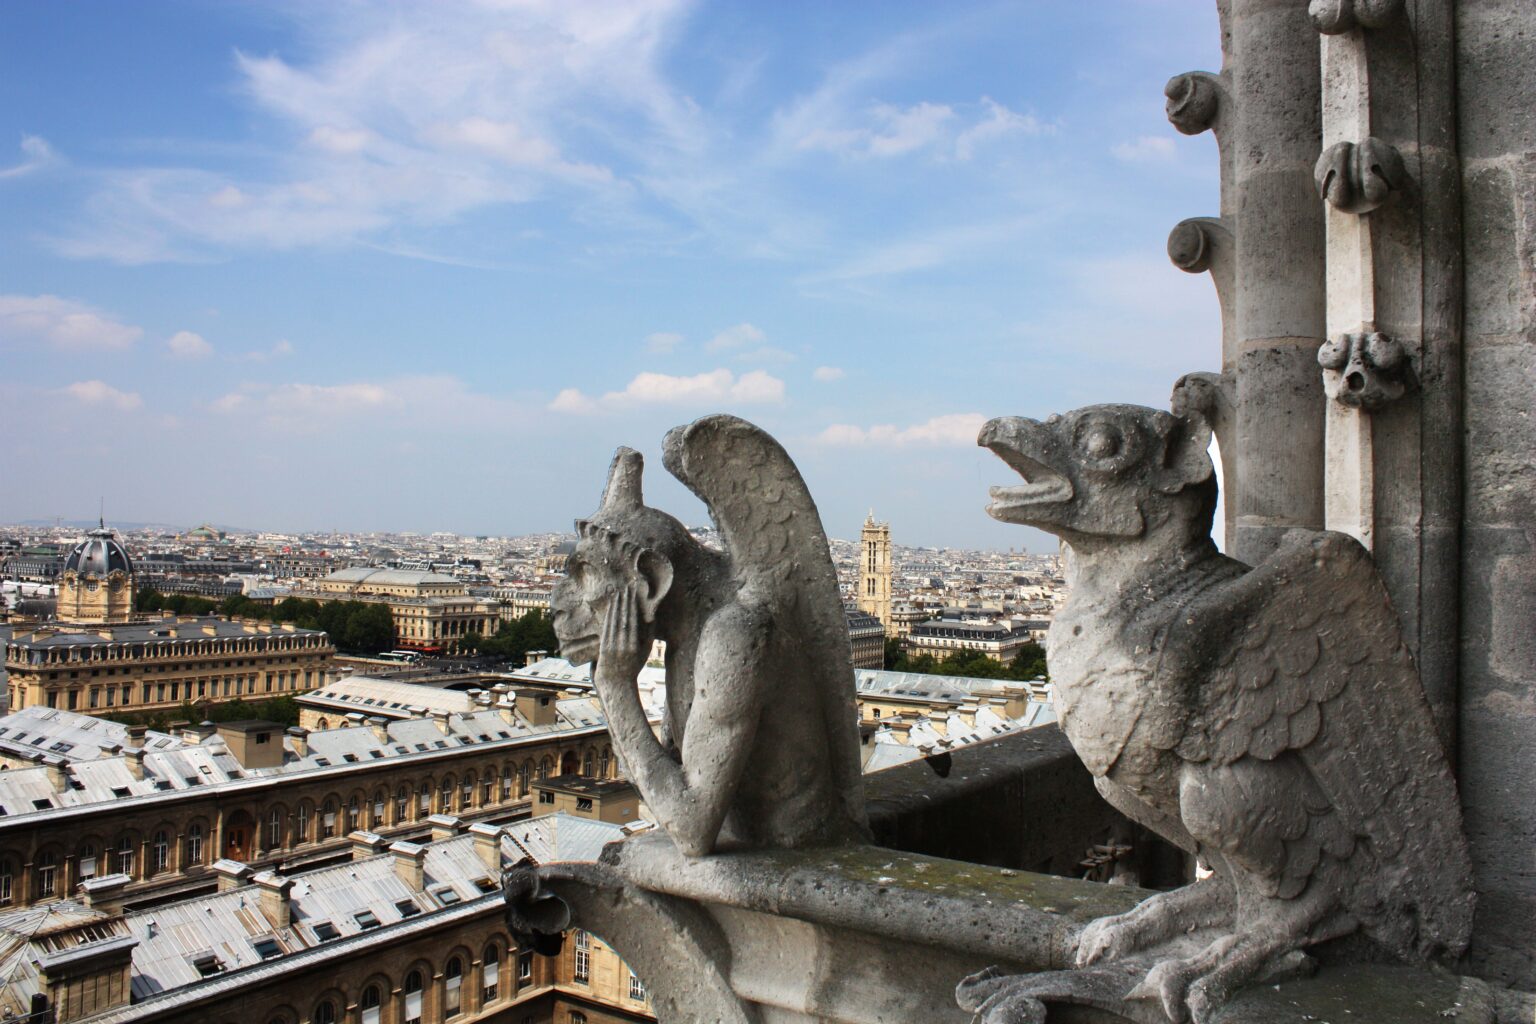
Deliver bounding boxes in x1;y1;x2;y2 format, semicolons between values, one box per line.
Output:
55;0;688;263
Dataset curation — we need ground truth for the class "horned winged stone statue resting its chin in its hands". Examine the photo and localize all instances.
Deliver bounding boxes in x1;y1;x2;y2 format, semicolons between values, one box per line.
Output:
550;416;866;857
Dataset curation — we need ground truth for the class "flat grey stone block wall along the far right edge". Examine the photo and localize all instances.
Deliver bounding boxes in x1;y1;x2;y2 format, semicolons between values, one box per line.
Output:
1455;0;1536;990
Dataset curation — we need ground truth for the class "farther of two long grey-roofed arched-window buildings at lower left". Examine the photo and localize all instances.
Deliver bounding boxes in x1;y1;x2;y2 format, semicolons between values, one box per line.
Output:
0;709;617;907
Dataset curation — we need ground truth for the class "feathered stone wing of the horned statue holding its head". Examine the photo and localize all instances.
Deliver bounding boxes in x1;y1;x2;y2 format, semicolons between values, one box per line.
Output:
662;413;865;820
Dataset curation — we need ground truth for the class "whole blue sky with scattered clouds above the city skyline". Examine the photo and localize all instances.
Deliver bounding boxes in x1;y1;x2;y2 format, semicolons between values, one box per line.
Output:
0;0;1220;550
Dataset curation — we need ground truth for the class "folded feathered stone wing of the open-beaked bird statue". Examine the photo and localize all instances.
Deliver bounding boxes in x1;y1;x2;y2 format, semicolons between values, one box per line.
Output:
1170;530;1473;960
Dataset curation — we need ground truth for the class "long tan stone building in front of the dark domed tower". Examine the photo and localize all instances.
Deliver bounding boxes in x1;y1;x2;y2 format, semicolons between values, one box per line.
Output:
5;616;336;712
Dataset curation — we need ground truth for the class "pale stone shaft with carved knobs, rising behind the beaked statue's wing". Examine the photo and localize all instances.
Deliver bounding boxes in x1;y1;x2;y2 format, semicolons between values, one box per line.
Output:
1313;0;1461;749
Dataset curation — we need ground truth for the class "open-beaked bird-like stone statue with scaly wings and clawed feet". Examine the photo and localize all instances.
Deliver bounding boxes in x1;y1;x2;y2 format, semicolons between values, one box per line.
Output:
958;405;1473;1024
